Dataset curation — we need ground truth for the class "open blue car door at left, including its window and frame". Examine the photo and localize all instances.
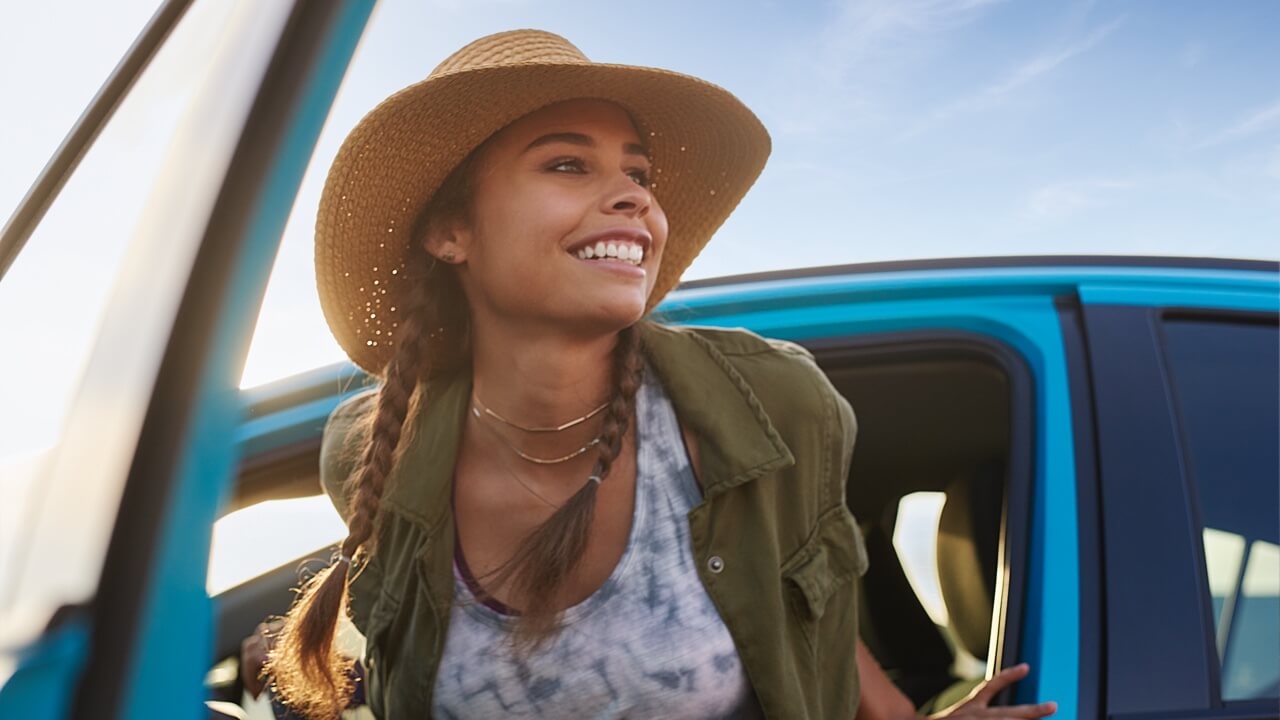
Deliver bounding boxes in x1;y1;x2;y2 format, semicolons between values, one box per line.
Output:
0;1;372;717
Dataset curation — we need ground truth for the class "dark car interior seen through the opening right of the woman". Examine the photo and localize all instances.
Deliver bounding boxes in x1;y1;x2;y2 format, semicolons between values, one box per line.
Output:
817;338;1028;711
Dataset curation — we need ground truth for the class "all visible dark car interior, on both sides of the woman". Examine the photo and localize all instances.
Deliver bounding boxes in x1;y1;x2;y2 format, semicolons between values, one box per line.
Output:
206;333;1032;711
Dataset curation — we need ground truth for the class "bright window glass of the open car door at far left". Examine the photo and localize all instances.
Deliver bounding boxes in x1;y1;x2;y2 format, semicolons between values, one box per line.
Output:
0;3;235;594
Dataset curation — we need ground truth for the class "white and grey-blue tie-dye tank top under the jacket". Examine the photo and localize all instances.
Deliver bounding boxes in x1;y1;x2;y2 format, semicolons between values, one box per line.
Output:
431;372;760;720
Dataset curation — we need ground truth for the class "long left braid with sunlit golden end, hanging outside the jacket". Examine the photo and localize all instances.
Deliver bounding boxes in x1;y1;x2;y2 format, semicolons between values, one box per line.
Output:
266;235;456;717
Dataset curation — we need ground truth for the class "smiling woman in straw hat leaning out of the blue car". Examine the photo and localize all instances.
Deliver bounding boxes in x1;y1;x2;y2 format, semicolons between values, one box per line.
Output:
270;31;1043;717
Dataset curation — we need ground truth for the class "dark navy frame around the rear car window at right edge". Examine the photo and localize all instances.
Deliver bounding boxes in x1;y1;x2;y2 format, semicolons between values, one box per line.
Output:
1083;299;1280;720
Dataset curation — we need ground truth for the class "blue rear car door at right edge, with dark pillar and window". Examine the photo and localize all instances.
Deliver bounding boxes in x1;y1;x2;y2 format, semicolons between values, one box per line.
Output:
1082;270;1280;719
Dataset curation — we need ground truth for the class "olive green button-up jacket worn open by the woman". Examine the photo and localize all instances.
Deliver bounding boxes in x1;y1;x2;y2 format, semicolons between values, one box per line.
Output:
321;323;867;720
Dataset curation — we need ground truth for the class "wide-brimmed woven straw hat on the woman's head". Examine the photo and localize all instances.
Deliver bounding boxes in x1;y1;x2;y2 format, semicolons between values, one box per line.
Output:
315;29;769;374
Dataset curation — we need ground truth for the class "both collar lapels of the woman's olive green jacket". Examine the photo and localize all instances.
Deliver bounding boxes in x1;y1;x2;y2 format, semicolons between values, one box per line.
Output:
373;322;795;533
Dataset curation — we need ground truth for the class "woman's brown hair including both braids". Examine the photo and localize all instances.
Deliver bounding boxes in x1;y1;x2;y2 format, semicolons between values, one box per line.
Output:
266;146;644;717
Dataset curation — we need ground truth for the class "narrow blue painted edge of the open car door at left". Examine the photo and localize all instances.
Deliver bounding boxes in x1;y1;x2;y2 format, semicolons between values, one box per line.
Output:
122;3;372;717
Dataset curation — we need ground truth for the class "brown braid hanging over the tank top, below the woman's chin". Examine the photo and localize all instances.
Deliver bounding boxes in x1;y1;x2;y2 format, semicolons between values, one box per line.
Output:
493;327;644;653
